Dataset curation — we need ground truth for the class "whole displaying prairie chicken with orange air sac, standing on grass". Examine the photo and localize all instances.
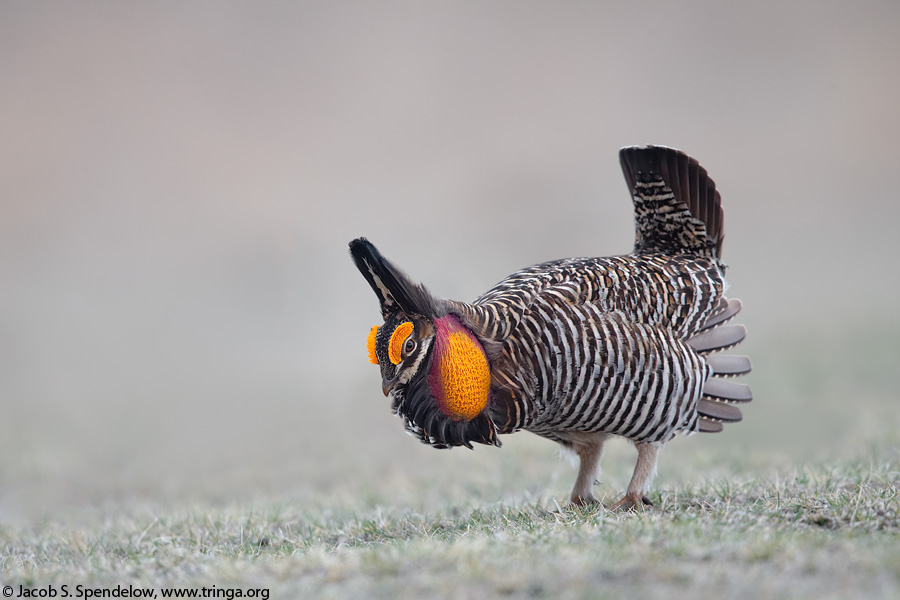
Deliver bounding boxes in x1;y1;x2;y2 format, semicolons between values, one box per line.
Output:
350;146;752;509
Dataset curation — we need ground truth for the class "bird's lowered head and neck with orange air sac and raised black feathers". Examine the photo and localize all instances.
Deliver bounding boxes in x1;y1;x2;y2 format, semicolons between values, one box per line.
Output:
350;238;500;448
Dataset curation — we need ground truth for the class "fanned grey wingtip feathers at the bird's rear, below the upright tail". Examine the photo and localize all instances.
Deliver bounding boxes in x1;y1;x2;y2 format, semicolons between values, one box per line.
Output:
688;298;753;433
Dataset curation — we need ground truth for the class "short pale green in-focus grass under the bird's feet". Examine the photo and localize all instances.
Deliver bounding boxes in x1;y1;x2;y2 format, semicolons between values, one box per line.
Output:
0;446;900;598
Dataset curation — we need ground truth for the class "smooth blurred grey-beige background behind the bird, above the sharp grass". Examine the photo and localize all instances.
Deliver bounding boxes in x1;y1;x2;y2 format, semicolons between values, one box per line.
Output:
0;0;900;521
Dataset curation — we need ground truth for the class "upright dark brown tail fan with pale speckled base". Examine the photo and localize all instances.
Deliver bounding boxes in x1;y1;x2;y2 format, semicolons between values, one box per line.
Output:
619;146;725;260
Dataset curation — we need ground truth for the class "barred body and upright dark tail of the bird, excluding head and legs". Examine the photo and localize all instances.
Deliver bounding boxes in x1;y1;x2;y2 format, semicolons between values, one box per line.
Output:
461;147;743;442
